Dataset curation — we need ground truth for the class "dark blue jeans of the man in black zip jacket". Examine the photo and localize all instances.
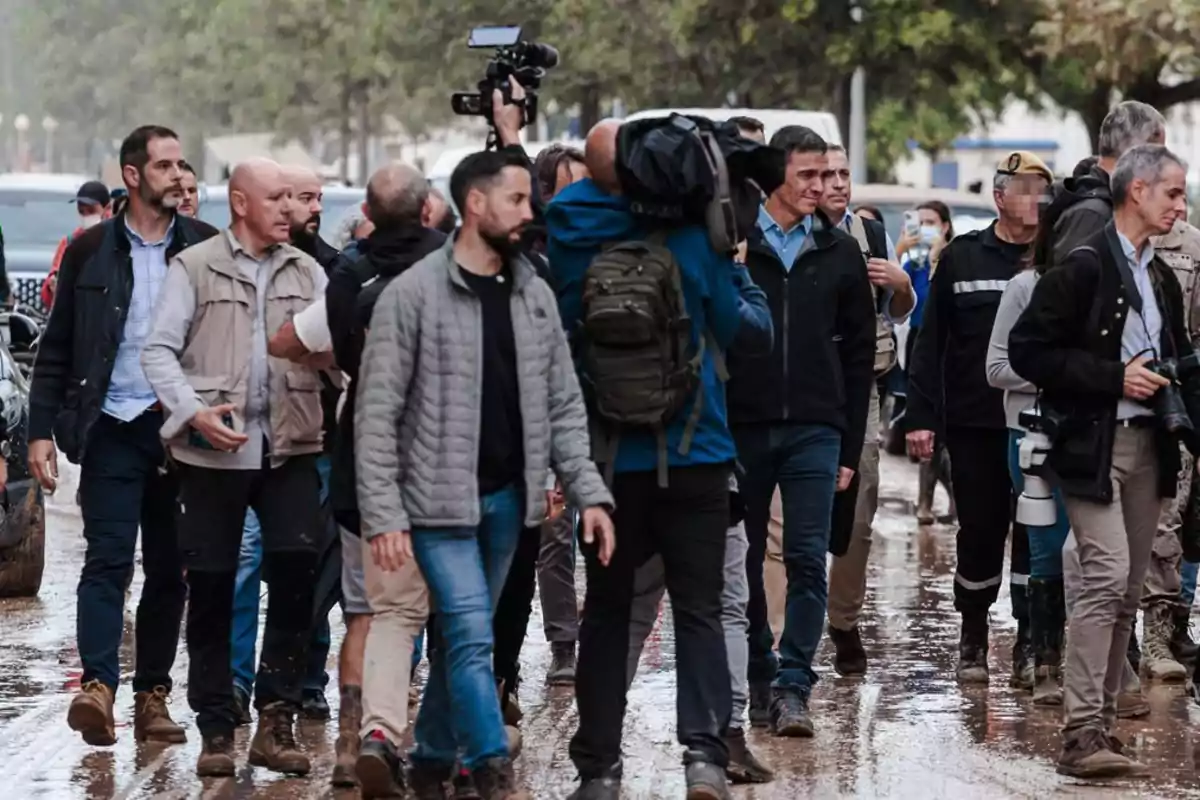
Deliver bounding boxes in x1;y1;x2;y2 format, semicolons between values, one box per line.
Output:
734;425;841;696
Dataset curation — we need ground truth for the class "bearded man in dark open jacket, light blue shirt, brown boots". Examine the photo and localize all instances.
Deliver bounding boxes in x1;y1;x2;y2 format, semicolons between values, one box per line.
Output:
29;126;217;745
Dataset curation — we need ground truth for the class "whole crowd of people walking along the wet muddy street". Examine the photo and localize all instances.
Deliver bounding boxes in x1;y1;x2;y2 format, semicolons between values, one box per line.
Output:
14;86;1200;800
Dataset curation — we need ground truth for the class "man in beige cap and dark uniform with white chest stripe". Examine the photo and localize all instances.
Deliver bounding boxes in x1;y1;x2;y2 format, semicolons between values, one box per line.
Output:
906;150;1052;690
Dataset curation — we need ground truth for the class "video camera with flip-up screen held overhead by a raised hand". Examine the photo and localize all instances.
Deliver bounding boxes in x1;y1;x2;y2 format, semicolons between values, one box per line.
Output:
450;25;558;145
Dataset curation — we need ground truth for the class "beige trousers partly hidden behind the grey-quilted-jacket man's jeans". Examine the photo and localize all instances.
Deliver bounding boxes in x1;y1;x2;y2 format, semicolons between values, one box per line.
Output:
361;539;430;747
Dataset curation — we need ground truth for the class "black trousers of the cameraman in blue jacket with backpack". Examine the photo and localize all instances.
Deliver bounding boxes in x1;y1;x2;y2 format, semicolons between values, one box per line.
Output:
570;464;732;780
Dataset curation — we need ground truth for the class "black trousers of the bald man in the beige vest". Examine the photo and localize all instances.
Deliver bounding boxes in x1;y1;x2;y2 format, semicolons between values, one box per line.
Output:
179;456;323;736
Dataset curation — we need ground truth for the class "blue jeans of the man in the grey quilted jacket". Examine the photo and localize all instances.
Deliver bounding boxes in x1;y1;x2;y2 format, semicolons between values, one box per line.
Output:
413;487;524;769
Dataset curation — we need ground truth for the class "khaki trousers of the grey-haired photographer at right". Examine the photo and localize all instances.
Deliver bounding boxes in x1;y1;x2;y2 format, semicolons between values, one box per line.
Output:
1063;427;1162;732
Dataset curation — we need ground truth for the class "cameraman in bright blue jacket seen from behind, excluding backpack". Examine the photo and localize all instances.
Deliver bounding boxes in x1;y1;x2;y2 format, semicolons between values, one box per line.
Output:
546;121;772;800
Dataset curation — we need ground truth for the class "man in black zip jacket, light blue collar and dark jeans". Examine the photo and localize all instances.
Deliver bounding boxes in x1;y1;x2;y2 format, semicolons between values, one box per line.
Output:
728;126;875;736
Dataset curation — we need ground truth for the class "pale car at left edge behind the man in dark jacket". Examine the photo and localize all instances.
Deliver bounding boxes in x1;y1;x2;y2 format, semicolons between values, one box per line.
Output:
0;173;90;309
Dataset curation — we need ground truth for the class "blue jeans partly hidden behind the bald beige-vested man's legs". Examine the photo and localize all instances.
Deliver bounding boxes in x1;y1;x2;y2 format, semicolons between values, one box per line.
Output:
230;456;330;696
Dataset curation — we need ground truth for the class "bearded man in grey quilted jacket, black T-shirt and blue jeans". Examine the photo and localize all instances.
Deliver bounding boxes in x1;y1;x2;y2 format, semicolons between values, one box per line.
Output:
354;151;614;800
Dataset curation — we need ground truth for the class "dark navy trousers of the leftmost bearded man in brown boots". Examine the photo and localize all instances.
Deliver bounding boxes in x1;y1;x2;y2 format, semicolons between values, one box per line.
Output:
77;411;187;692
